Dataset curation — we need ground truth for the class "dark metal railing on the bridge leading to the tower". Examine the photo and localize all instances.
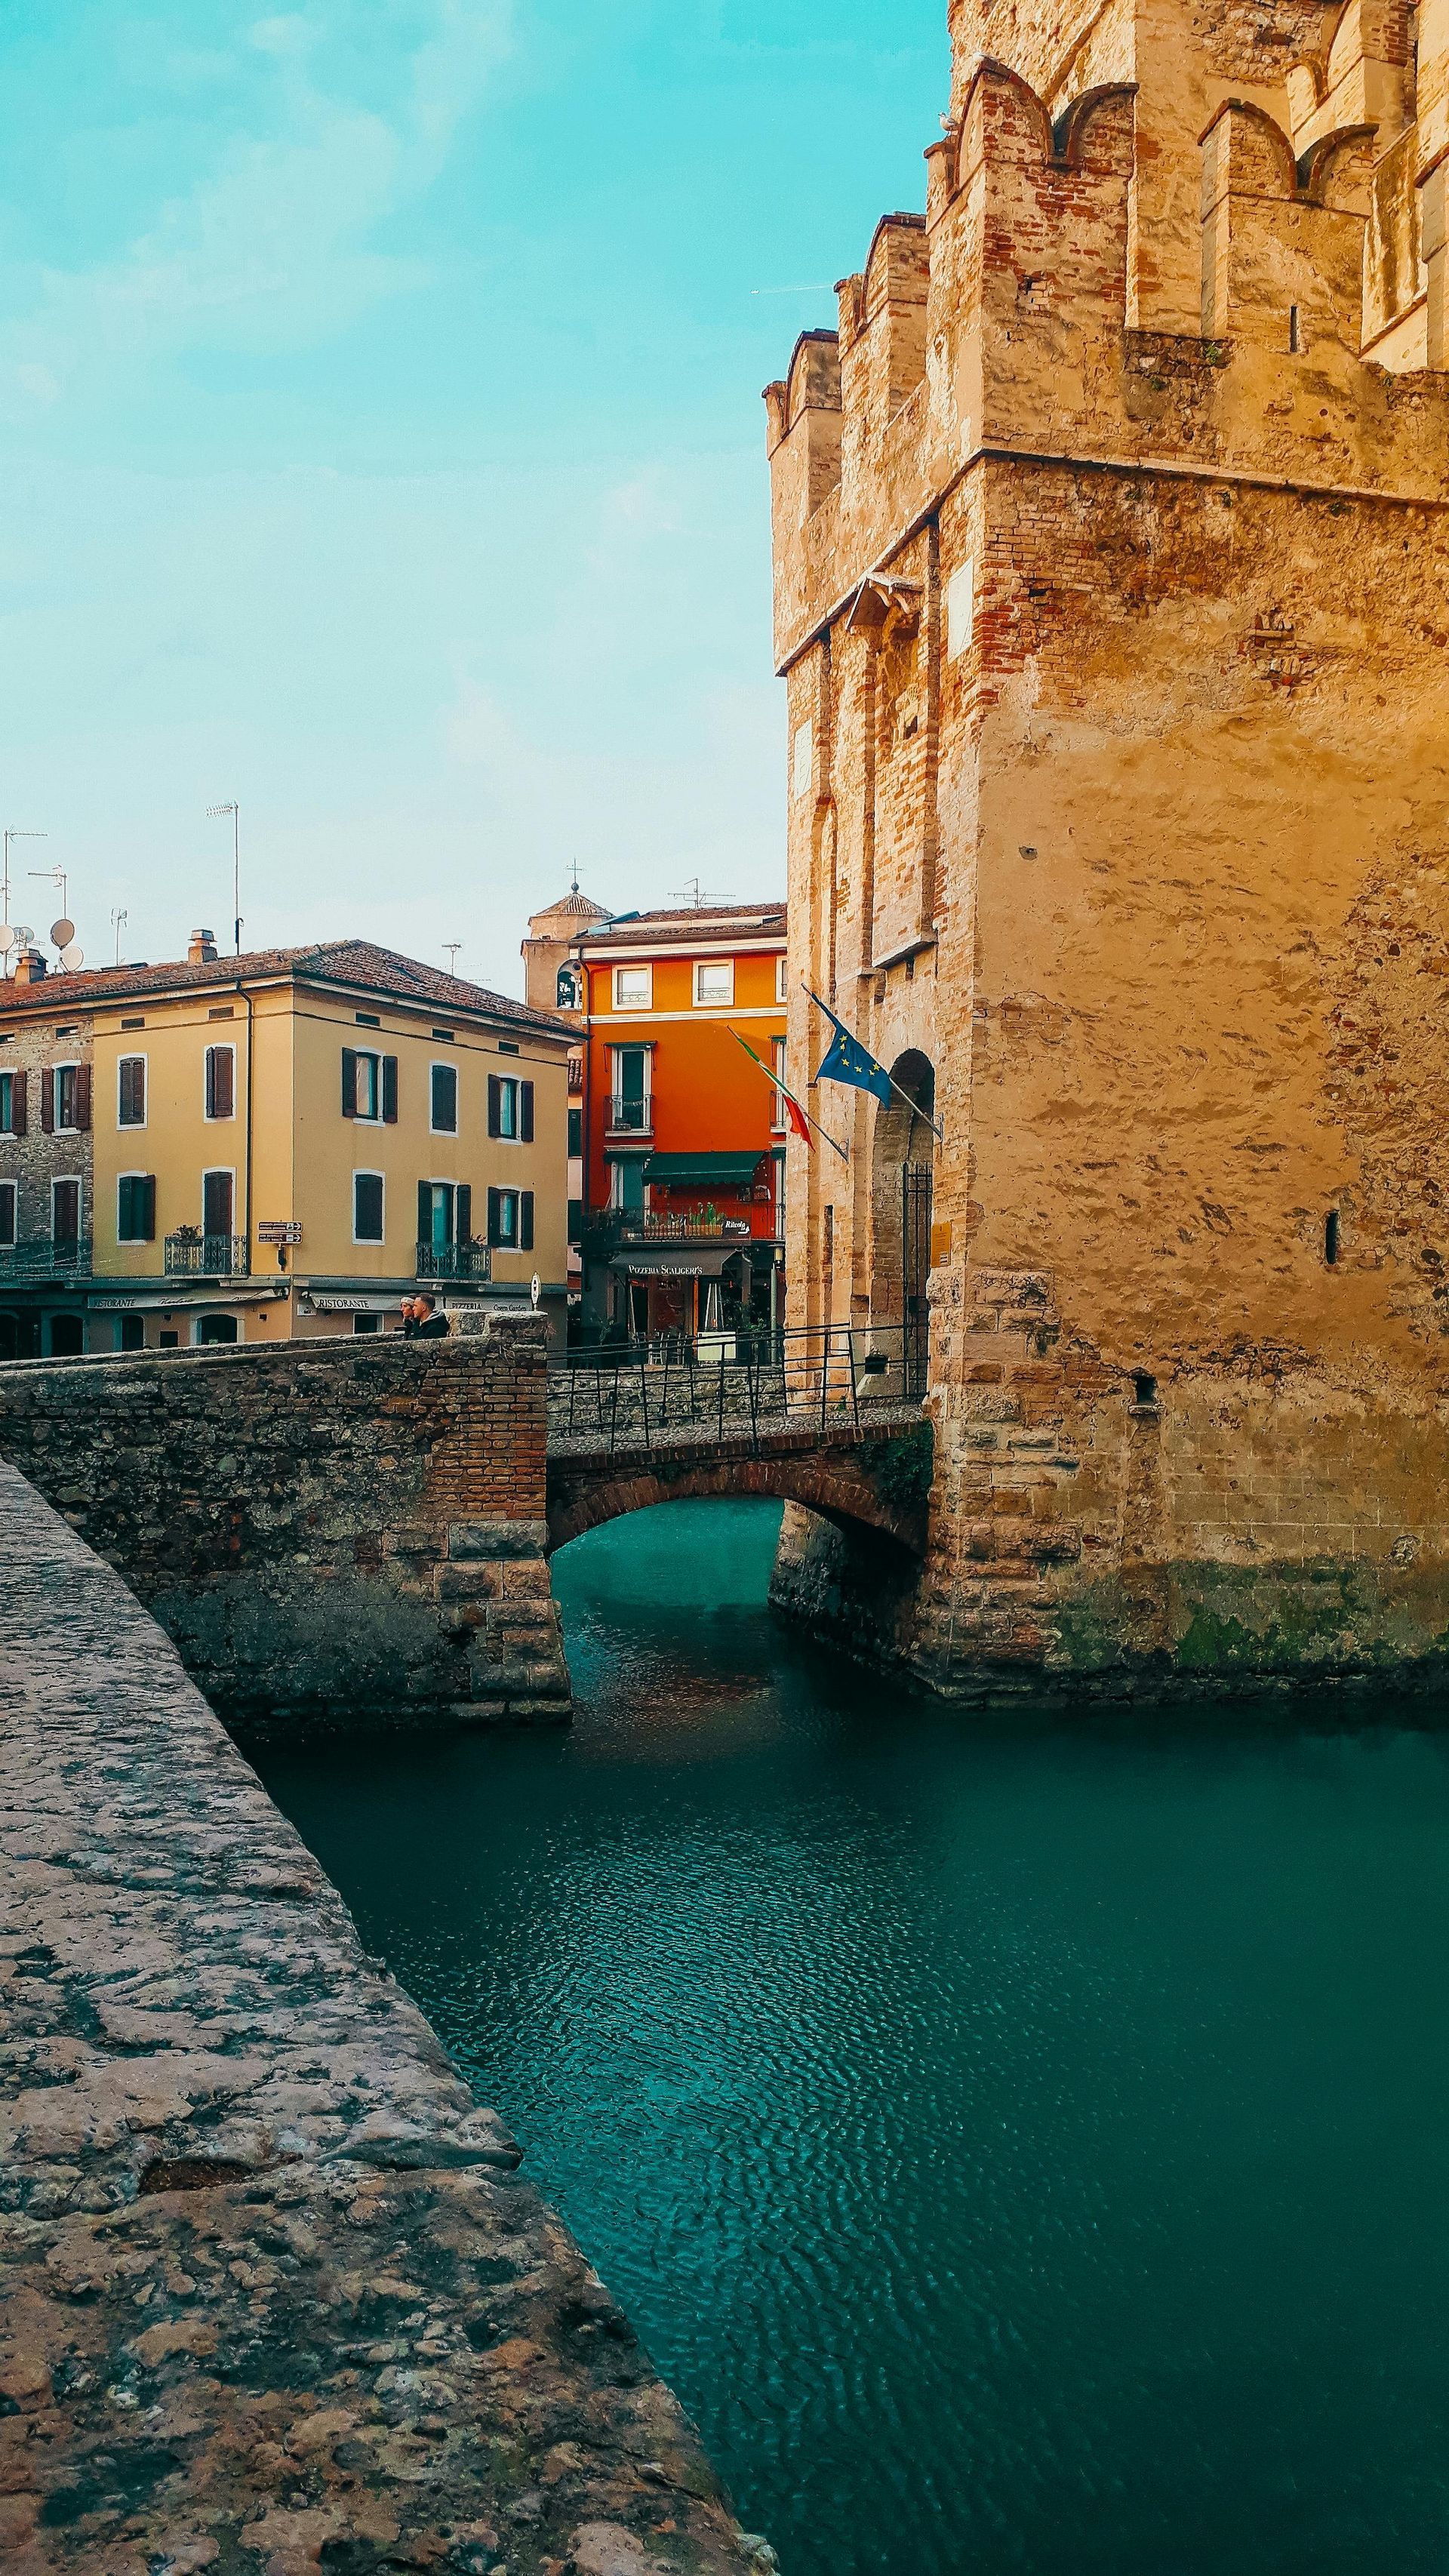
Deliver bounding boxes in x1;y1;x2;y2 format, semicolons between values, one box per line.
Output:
548;1324;927;1453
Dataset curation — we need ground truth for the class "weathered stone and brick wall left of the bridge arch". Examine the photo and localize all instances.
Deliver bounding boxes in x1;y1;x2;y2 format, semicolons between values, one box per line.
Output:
0;1316;569;1726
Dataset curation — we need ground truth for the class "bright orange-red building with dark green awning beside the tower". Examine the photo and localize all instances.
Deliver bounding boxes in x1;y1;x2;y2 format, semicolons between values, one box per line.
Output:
522;888;785;1337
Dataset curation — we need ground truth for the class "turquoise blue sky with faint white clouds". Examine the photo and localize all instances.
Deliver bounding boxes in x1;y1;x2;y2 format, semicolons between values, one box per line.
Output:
0;0;947;989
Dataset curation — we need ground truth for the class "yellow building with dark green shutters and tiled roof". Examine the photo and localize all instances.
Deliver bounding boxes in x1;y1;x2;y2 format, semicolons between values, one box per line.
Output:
0;933;569;1350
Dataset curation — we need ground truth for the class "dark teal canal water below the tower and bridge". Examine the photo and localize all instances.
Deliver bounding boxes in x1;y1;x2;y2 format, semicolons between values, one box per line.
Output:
263;1504;1449;2576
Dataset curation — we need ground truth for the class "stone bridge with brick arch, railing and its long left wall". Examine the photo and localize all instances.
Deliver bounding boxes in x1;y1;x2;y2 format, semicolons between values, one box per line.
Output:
0;1316;929;1728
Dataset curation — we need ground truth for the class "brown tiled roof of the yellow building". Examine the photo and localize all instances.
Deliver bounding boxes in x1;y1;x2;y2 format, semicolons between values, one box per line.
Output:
0;940;574;1036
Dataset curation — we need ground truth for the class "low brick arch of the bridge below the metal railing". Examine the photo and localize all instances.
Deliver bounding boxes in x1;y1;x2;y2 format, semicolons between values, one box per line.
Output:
548;1451;927;1559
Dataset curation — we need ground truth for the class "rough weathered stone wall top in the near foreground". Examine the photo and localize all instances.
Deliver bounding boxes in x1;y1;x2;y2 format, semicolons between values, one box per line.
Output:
0;1466;775;2576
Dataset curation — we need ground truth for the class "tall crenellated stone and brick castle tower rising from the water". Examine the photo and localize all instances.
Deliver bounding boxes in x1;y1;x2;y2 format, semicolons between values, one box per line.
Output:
764;0;1449;1690
